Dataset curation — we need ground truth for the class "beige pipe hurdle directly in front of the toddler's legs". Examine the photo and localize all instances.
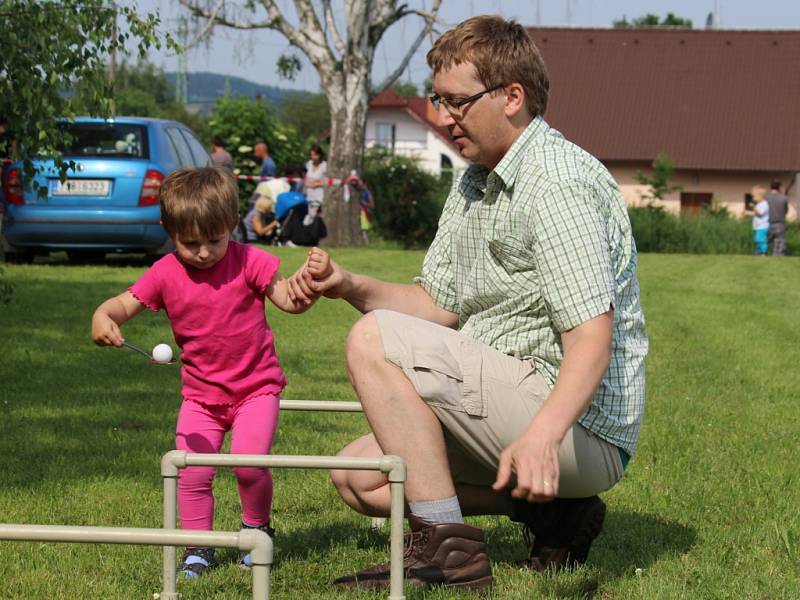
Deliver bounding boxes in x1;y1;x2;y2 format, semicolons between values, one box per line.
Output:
160;450;406;600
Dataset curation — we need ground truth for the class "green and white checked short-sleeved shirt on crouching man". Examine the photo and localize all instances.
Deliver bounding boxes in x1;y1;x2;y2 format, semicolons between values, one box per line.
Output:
417;117;647;455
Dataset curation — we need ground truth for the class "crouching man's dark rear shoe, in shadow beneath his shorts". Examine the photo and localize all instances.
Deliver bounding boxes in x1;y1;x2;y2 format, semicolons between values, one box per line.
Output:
511;496;606;573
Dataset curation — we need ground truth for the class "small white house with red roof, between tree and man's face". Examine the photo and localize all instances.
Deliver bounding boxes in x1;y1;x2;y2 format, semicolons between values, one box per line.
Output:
364;88;469;175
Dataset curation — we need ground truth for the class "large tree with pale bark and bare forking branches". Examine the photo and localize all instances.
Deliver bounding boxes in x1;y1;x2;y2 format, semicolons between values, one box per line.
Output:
179;0;442;246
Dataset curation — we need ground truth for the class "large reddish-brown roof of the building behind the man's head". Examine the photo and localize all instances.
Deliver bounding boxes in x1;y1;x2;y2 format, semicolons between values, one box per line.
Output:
528;28;800;170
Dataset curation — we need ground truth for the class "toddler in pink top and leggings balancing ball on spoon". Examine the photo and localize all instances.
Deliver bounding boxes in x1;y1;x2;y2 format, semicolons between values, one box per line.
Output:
92;167;328;577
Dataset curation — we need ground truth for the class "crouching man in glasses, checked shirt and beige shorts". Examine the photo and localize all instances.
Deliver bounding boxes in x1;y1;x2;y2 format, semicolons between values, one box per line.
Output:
290;16;647;589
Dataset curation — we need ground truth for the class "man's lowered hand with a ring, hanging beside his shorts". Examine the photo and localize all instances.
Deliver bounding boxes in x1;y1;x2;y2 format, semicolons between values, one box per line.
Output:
492;430;561;502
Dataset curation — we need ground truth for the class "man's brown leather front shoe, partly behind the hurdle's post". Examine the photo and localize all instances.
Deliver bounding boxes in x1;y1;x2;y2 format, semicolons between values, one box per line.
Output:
334;515;492;590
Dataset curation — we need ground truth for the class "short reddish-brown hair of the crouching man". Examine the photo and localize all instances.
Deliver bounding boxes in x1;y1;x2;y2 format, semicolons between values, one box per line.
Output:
427;15;550;117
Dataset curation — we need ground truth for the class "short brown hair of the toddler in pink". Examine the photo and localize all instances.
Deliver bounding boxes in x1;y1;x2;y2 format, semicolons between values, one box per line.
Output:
159;167;239;238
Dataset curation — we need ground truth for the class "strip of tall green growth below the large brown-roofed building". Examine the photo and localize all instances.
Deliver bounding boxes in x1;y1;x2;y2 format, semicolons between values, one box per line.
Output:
628;205;800;255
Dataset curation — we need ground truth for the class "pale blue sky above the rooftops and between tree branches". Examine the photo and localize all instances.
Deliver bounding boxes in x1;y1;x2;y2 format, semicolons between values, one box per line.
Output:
130;0;800;91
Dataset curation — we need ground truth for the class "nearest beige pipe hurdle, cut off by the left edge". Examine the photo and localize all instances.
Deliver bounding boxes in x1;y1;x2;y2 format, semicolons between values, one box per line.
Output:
0;524;272;600
